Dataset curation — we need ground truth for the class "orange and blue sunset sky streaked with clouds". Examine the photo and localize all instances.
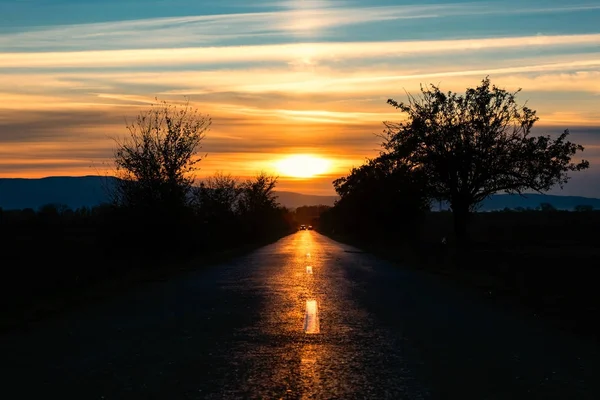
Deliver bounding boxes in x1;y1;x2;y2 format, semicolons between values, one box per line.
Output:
0;0;600;197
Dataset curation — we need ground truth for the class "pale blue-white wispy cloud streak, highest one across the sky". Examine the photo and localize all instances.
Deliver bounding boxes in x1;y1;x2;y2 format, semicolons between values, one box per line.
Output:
0;1;600;51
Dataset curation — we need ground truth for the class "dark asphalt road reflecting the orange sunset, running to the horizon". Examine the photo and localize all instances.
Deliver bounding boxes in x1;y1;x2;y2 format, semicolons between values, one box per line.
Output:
0;231;600;400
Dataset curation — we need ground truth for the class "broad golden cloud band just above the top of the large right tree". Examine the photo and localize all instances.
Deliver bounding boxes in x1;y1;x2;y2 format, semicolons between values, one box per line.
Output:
0;55;600;109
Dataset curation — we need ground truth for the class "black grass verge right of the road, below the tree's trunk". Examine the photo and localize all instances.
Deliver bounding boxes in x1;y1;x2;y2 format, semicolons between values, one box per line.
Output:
325;233;600;340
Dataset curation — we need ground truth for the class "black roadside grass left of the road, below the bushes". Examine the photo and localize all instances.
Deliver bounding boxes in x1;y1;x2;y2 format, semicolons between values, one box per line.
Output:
0;229;289;333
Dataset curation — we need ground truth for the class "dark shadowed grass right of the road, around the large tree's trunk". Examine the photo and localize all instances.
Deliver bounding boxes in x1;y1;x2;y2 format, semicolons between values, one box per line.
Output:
322;212;600;339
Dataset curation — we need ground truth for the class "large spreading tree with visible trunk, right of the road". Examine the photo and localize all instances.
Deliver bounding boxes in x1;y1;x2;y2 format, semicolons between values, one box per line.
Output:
383;77;589;242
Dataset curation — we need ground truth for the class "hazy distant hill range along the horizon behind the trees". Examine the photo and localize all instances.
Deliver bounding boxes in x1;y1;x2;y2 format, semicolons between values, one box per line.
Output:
0;176;600;211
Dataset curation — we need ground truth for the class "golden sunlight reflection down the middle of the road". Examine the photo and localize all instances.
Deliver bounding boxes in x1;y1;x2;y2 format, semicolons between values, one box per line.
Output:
225;231;421;399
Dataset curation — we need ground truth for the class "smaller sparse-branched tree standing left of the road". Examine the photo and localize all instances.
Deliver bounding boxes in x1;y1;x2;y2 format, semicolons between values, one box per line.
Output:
115;101;211;210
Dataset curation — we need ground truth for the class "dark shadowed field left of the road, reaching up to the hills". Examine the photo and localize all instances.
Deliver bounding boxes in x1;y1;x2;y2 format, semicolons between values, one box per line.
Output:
0;208;289;330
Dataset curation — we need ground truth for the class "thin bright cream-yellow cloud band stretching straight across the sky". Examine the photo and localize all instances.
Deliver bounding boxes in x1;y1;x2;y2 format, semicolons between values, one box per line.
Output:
0;34;600;68
